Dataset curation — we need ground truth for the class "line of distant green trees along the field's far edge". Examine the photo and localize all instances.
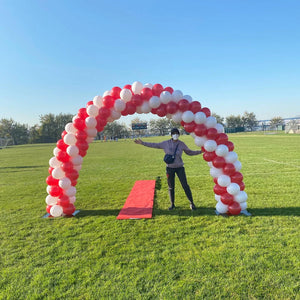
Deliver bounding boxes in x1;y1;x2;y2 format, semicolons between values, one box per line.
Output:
0;112;283;145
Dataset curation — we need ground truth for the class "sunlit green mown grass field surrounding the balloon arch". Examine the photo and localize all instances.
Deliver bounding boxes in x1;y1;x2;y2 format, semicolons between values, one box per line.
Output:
0;134;300;299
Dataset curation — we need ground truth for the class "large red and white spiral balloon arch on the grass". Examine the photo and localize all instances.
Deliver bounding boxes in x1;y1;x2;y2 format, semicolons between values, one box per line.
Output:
46;81;248;217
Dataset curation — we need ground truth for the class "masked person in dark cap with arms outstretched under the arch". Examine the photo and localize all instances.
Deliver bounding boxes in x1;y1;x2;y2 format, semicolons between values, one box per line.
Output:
134;128;202;210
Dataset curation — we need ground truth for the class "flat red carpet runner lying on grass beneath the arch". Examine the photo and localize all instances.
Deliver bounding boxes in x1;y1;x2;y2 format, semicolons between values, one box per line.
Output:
117;180;155;220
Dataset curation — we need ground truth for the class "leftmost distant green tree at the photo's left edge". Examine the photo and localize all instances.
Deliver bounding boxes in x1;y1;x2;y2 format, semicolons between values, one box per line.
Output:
0;119;29;145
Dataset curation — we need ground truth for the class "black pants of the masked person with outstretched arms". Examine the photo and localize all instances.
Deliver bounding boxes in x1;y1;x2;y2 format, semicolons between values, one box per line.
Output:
167;167;193;204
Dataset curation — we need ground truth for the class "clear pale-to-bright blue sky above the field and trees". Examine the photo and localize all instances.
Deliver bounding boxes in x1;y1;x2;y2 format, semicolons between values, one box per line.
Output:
0;0;300;126
